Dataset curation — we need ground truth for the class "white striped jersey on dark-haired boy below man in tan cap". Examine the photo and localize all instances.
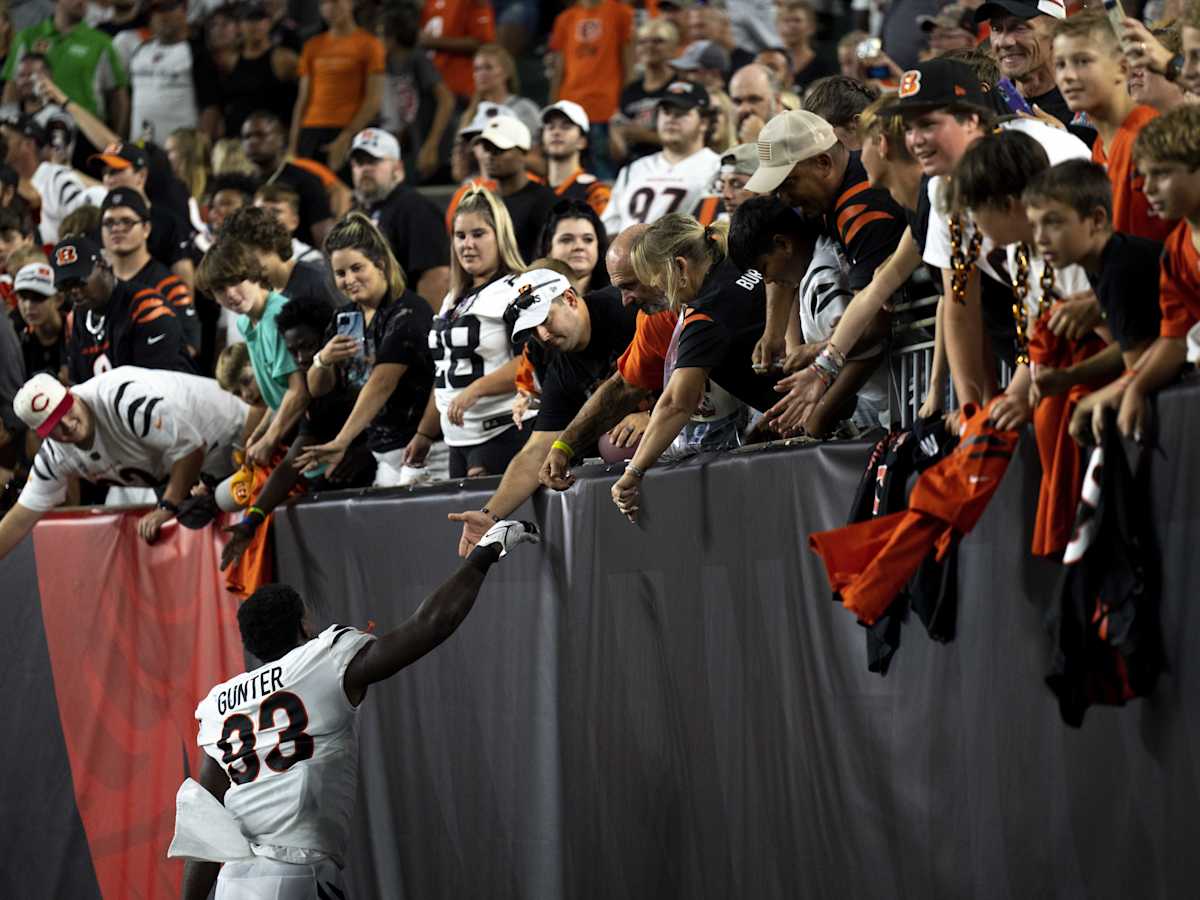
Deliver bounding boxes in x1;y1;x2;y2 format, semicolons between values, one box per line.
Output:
798;236;890;427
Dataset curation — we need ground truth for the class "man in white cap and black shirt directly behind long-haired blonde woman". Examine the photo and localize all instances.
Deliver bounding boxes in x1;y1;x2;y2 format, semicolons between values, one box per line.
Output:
473;115;558;259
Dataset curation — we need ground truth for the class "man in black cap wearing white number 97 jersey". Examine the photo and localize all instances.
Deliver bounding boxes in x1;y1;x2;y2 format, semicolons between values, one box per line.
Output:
601;82;721;234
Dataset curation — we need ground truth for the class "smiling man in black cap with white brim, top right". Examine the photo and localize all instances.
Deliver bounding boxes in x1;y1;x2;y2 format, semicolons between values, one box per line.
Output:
976;0;1096;146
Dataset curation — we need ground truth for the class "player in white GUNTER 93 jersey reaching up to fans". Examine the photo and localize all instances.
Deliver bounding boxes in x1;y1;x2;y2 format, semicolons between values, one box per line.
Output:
168;521;539;900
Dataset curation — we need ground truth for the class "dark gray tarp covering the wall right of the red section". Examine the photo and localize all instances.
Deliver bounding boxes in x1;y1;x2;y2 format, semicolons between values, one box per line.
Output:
270;385;1200;900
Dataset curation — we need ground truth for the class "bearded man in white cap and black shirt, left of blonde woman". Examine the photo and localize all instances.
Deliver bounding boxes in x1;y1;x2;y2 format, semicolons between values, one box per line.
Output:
350;128;450;306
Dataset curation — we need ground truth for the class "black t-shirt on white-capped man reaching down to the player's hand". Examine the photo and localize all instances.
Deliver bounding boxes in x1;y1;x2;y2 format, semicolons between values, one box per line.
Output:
533;288;637;431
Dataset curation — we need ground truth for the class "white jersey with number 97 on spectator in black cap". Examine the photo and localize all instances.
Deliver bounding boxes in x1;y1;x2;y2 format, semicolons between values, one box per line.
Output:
601;146;721;235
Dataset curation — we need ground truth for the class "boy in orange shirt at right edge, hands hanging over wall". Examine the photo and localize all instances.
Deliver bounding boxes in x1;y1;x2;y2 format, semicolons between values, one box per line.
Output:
1092;106;1200;440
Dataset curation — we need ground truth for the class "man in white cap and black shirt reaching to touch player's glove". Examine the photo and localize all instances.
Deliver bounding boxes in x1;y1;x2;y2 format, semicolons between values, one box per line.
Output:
449;259;637;557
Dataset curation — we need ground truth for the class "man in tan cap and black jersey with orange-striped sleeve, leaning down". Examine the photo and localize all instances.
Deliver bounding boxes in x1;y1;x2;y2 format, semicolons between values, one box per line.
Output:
746;109;907;428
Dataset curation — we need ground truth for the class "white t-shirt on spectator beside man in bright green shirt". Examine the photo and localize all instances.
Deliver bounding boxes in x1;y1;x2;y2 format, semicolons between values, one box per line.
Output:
113;29;199;144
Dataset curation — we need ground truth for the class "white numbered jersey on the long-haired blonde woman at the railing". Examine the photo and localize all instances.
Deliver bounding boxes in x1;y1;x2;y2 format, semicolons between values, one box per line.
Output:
430;275;538;446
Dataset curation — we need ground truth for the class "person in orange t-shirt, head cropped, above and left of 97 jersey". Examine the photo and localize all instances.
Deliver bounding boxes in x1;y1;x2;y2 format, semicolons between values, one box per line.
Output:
550;0;634;179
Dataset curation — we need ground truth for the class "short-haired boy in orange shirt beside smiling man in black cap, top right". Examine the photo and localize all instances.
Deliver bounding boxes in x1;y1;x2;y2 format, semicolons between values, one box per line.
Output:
1054;12;1176;241
